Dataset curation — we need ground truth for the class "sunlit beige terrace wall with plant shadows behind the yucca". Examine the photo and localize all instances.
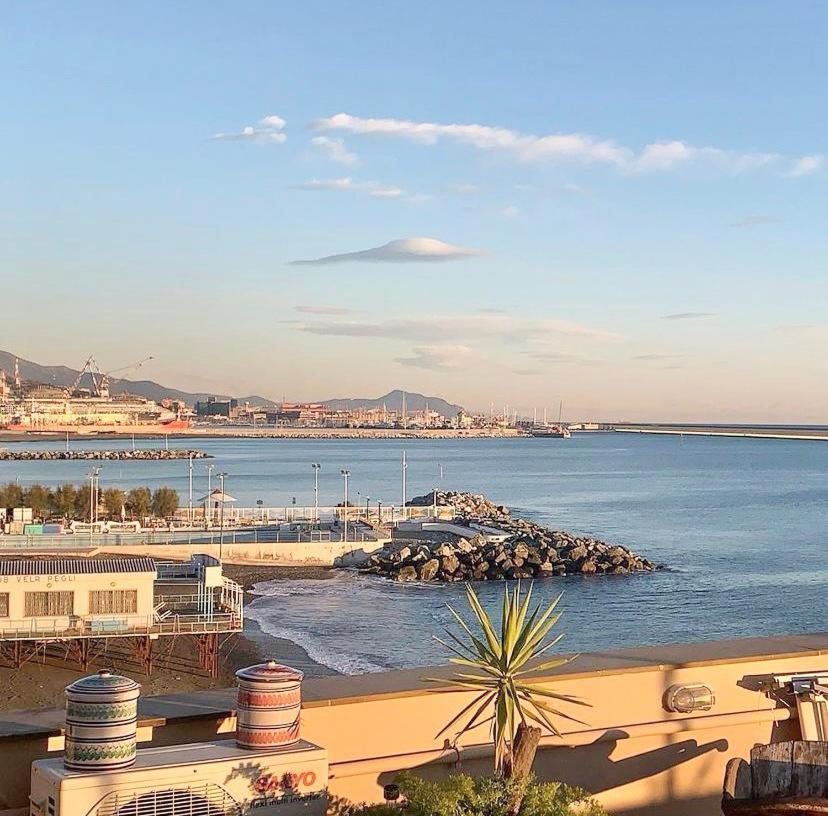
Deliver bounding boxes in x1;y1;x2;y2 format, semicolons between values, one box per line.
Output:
0;635;828;816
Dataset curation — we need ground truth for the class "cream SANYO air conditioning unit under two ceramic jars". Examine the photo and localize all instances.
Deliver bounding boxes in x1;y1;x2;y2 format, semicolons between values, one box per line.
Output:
29;739;328;816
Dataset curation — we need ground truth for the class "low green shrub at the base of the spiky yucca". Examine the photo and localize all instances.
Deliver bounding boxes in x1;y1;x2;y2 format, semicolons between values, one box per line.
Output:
340;773;605;816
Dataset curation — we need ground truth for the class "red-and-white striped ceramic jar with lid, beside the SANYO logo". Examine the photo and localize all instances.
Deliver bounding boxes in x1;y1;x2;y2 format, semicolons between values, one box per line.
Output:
236;660;303;748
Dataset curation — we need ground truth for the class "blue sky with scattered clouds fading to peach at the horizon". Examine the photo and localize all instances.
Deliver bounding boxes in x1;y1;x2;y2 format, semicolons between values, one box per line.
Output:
0;0;828;423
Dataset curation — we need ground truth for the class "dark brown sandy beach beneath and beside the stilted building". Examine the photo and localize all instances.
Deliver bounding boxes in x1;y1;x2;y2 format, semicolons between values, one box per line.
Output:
0;565;336;711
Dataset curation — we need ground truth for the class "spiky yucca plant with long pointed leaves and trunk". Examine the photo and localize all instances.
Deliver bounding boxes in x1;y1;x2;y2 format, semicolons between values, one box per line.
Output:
426;582;587;778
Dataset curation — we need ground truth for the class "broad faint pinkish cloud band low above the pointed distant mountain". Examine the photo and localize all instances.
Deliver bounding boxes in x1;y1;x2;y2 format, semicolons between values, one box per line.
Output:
301;313;618;342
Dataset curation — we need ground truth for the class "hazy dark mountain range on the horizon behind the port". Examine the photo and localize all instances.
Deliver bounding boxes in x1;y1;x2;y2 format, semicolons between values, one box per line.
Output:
0;351;460;416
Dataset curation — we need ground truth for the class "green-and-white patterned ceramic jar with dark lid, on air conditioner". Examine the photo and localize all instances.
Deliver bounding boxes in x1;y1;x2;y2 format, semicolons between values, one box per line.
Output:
63;671;141;771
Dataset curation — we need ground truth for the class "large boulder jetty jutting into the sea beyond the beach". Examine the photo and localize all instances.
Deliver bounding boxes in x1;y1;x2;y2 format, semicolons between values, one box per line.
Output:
362;491;657;582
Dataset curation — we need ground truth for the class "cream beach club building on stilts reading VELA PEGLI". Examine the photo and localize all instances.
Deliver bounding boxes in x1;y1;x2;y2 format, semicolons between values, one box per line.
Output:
0;555;242;674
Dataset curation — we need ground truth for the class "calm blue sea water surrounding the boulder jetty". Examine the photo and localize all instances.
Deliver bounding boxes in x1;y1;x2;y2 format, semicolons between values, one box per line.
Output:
0;433;828;672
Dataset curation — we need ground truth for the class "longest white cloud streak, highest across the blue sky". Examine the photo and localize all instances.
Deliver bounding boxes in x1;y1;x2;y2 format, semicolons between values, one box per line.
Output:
311;113;814;173
